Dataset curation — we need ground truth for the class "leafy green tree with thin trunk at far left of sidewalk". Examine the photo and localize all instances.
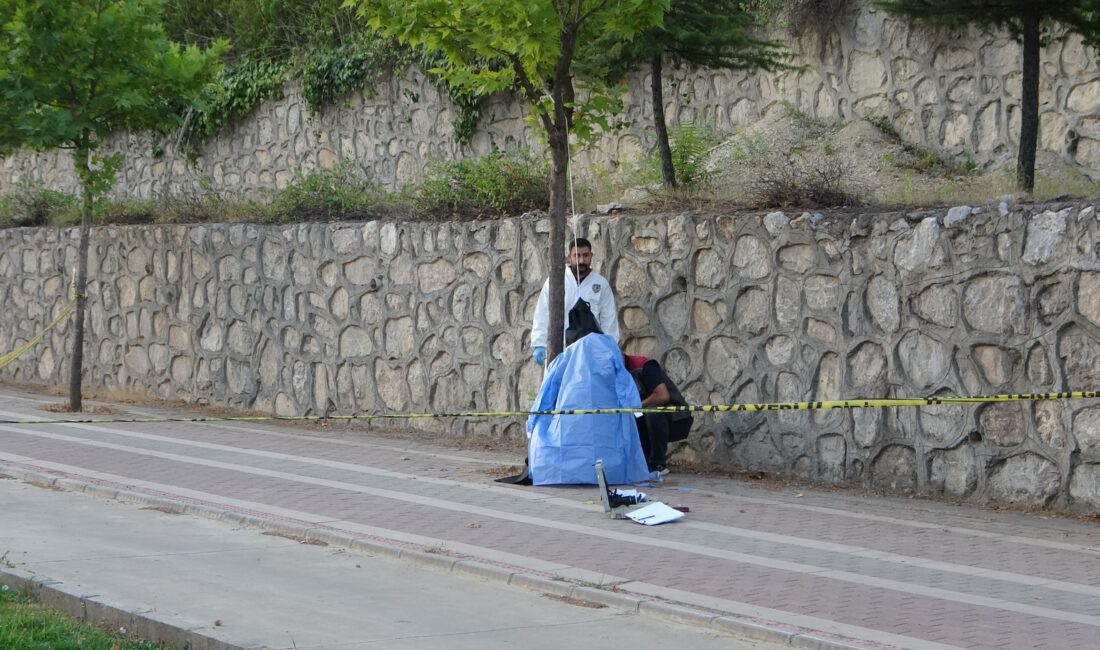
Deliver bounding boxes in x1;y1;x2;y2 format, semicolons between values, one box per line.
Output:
0;0;222;411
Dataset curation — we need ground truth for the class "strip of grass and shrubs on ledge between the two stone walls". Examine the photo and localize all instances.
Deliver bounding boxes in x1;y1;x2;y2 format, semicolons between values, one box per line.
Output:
0;140;1100;228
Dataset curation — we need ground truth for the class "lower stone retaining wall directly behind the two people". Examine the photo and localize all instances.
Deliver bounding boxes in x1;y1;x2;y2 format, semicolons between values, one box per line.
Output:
0;205;1100;508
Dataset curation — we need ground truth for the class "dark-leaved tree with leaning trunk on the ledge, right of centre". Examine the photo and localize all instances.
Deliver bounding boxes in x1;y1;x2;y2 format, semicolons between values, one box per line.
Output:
596;0;792;188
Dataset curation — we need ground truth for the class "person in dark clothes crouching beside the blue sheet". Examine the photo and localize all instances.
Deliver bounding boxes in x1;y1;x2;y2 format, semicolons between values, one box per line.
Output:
624;354;695;476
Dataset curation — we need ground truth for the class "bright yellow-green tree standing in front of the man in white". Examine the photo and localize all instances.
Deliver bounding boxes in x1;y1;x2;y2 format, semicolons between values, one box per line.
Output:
356;0;668;360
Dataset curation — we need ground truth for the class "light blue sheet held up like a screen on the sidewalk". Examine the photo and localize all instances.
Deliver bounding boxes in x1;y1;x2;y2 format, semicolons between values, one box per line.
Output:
527;334;649;485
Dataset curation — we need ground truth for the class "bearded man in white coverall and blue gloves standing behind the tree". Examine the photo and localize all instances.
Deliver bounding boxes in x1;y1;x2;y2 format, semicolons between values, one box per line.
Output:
531;238;618;365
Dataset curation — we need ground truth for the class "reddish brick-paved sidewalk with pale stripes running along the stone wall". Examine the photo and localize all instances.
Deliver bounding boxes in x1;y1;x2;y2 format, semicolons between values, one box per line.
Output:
0;390;1100;648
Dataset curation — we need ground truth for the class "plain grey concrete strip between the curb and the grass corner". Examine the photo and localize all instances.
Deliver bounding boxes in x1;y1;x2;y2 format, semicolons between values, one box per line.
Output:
0;472;780;650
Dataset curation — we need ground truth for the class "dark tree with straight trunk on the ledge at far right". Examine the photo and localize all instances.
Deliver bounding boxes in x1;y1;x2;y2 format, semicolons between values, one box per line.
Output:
875;0;1100;194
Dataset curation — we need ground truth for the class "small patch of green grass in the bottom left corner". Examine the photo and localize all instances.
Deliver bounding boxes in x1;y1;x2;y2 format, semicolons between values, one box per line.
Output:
0;585;170;650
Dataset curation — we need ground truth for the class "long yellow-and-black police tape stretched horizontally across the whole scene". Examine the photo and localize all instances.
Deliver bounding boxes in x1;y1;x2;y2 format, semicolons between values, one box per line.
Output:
0;390;1100;425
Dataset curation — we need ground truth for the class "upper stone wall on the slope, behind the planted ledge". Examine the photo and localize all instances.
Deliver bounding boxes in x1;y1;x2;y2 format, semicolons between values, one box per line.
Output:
0;7;1100;197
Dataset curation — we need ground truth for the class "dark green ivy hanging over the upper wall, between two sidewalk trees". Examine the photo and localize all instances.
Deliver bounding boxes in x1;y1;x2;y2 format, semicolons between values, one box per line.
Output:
165;0;484;148
